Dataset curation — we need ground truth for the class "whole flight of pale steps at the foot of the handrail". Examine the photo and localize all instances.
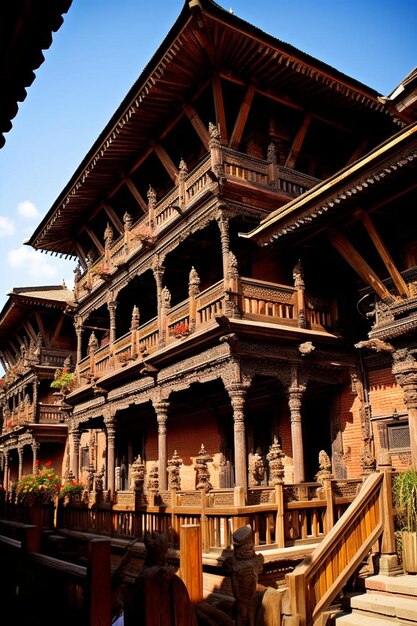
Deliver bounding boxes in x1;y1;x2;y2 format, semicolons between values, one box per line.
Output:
334;574;417;626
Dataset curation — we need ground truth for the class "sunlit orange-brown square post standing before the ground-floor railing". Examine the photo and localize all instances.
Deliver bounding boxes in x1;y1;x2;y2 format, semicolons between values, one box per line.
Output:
180;524;203;604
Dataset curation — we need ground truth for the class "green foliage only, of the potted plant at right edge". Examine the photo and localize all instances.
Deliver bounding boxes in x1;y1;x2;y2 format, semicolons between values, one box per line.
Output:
392;467;417;532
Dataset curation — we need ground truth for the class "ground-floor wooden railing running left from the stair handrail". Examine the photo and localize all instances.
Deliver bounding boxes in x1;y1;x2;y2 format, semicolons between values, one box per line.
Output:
48;479;362;552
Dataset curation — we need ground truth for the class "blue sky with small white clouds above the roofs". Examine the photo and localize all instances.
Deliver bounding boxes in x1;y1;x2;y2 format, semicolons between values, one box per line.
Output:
0;0;417;308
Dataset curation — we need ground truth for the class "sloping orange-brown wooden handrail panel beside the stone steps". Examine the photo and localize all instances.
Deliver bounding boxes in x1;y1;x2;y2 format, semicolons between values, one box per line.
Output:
286;473;384;626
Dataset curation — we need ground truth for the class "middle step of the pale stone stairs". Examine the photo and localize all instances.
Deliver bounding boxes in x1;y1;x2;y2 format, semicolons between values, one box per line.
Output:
350;593;417;626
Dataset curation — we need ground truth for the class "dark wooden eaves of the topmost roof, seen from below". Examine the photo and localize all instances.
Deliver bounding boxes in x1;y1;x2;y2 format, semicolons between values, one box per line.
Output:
27;0;401;256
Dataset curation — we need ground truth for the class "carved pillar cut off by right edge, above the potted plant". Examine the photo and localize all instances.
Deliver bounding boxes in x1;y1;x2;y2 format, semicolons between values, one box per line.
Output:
392;348;417;469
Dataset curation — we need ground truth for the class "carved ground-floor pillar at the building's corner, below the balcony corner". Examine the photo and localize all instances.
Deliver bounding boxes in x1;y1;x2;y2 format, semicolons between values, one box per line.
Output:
227;383;248;491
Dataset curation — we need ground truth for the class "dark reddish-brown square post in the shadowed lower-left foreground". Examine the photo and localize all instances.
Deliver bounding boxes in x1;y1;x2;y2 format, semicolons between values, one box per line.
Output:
87;538;111;626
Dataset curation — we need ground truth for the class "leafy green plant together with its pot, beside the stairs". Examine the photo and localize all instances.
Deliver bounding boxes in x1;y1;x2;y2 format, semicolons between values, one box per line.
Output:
392;467;417;574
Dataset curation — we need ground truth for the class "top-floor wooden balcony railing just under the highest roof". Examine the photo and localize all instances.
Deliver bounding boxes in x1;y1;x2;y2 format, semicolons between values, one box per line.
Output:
74;148;319;301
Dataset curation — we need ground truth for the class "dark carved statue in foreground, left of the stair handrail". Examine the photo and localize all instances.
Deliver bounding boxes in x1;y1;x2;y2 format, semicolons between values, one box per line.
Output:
225;525;264;626
